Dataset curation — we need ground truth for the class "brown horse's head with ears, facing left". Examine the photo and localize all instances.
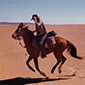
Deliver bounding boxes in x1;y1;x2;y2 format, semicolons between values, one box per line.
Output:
12;23;28;40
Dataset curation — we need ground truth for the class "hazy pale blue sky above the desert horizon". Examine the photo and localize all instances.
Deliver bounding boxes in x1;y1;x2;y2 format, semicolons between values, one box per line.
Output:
0;0;85;24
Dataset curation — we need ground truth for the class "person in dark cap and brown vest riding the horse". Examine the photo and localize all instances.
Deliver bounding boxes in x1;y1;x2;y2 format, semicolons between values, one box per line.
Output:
31;14;47;58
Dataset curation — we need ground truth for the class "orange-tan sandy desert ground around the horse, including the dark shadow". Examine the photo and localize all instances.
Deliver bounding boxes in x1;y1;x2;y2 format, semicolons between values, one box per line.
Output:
0;25;85;85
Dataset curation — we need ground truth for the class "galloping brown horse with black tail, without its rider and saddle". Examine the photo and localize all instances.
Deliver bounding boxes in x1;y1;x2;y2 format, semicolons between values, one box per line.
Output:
12;23;82;78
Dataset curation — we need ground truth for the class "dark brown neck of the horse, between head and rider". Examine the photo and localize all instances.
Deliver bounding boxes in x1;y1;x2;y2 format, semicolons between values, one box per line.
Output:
23;32;34;46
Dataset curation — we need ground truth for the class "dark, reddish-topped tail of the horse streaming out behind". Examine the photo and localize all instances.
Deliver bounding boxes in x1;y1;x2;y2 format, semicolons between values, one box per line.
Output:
67;41;83;59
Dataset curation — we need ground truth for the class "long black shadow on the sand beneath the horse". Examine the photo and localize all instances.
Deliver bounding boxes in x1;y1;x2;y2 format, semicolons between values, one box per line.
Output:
0;77;69;85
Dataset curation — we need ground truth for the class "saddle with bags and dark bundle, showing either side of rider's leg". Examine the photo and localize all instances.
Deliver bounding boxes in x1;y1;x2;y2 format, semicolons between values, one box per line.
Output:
32;31;56;48
